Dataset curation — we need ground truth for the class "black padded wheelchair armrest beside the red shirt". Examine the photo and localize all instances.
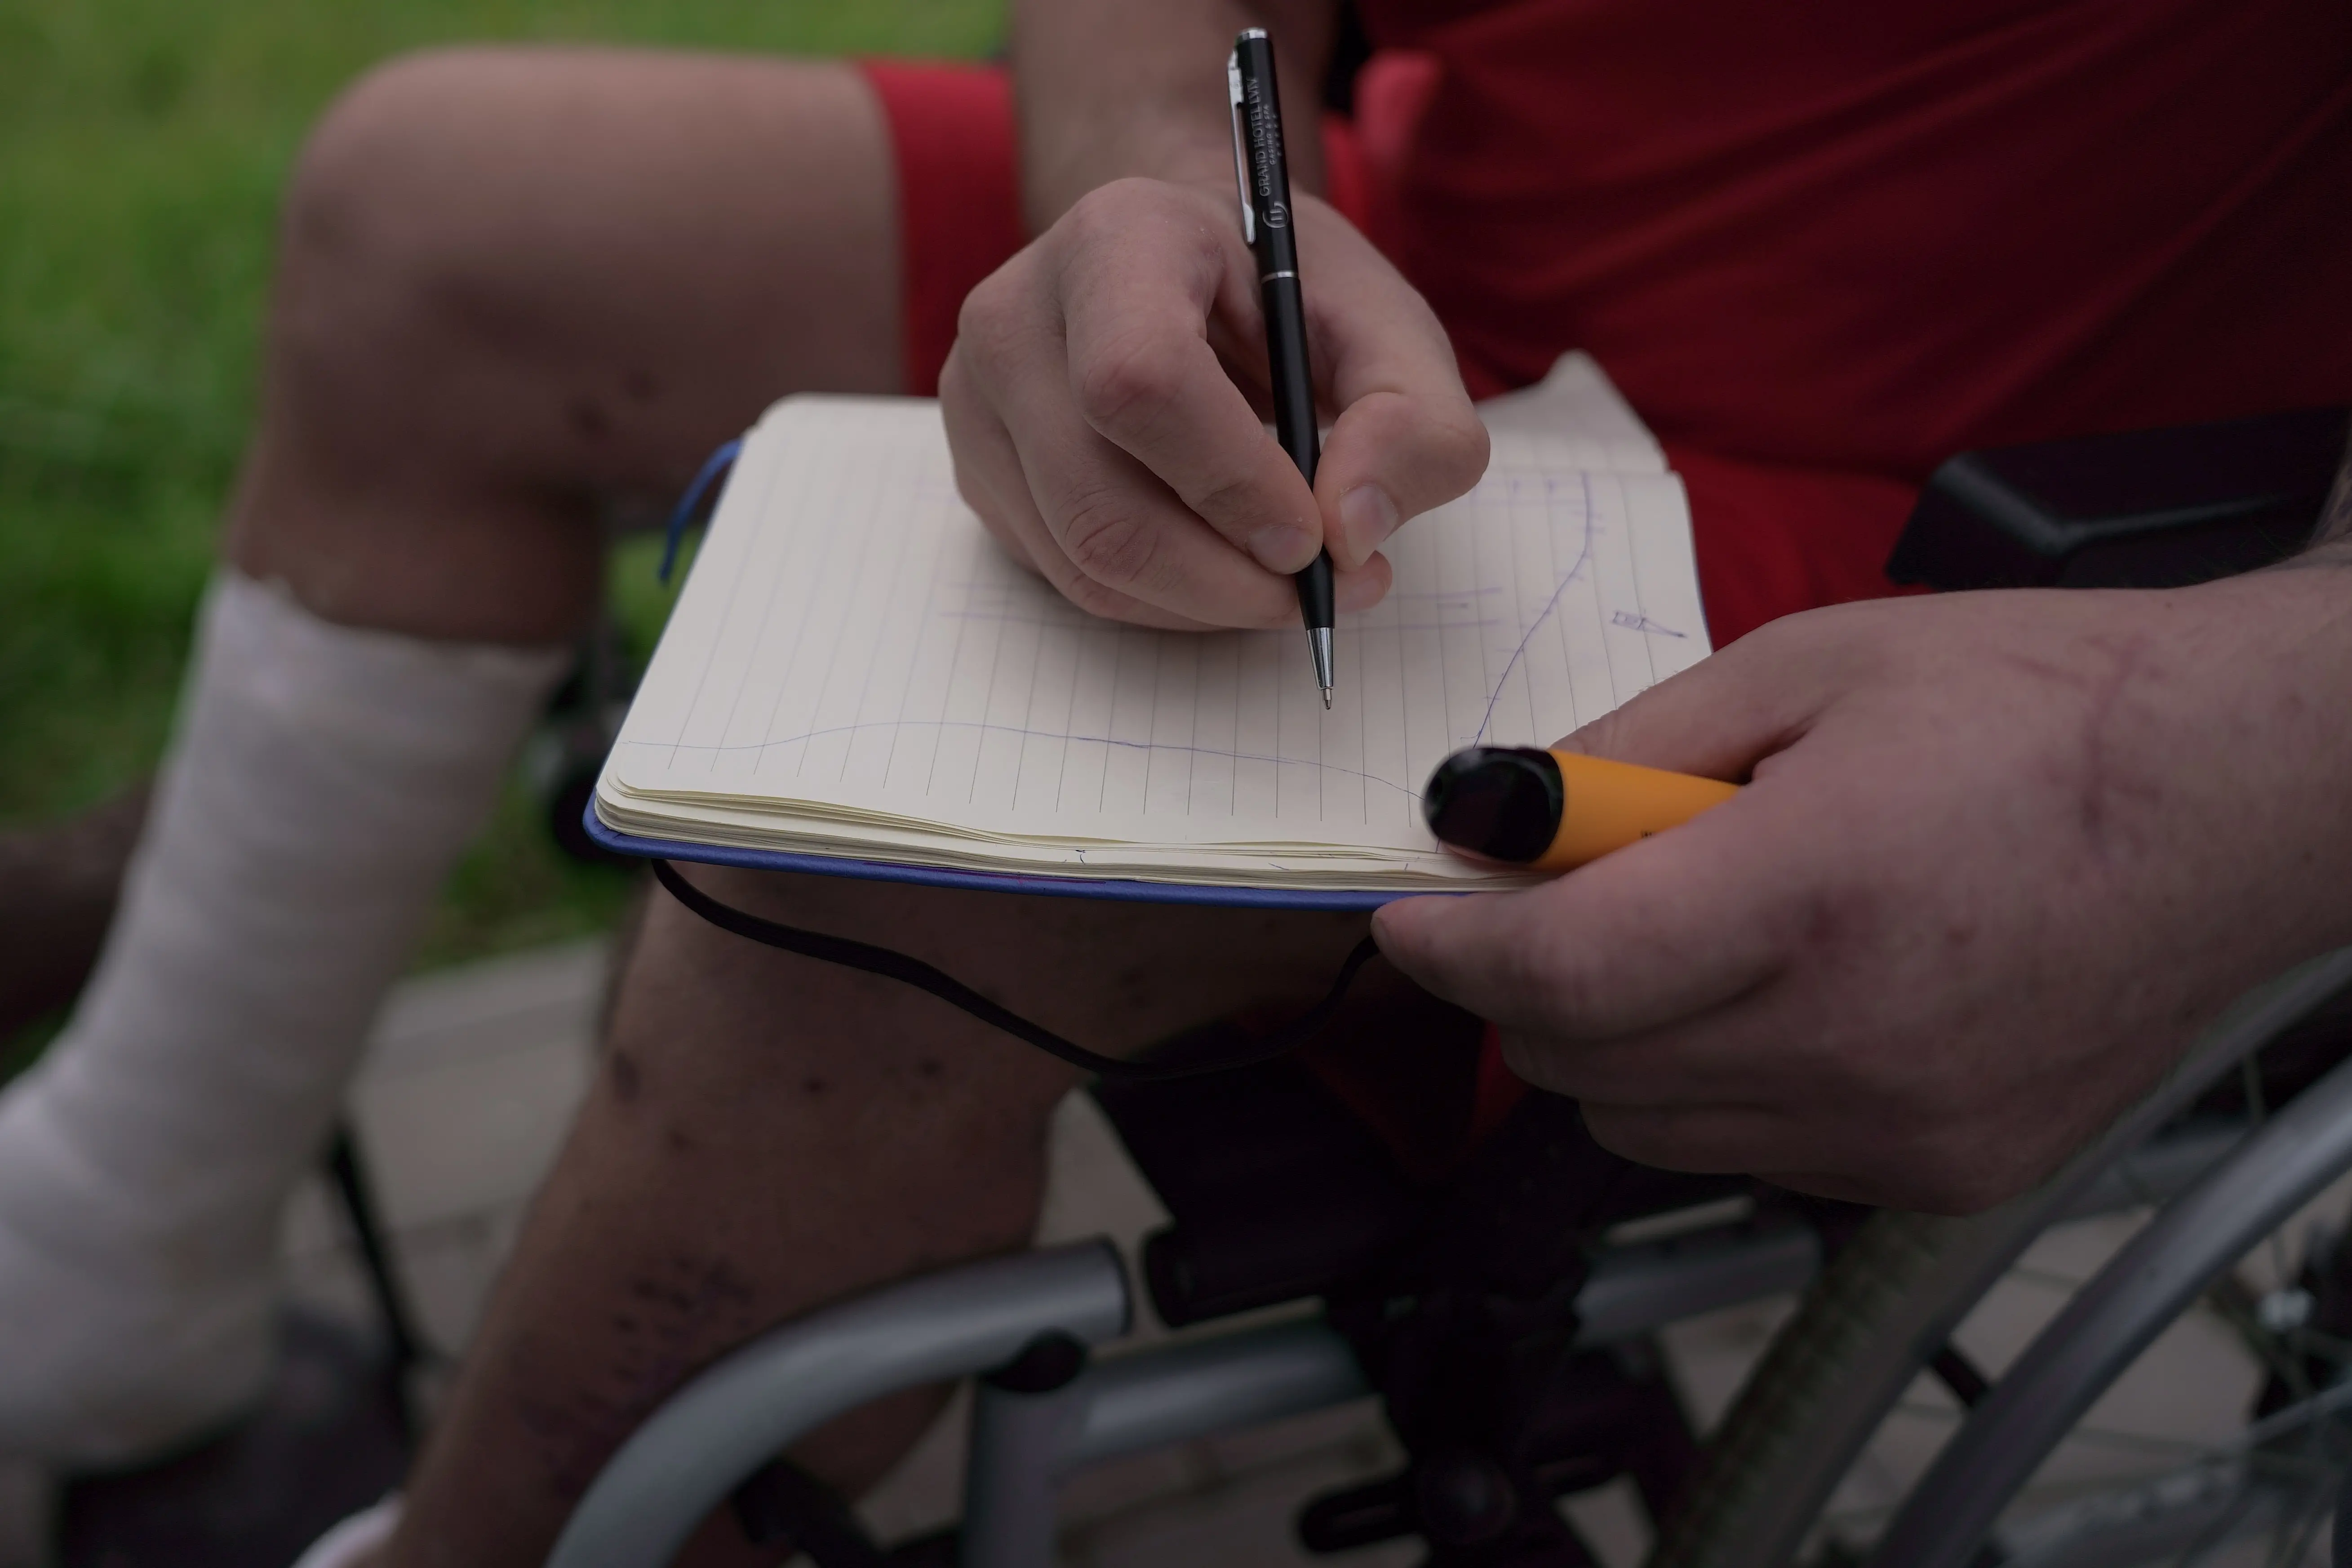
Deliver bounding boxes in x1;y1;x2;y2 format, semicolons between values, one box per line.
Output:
1886;409;2348;588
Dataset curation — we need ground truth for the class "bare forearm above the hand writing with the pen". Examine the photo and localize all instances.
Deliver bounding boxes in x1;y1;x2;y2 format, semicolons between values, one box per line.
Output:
1012;0;1336;231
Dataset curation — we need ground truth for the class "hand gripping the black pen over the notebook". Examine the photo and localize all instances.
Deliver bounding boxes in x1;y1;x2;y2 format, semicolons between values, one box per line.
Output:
938;179;1487;628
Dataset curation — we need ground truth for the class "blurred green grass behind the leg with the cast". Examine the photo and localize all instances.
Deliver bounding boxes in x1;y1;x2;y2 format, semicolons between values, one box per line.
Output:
0;0;1002;961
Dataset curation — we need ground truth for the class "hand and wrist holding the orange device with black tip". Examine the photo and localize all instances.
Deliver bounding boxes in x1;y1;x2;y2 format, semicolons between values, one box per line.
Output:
1374;567;2352;1211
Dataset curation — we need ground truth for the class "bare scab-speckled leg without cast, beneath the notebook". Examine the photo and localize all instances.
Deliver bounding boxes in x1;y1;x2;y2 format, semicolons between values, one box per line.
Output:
391;870;1397;1568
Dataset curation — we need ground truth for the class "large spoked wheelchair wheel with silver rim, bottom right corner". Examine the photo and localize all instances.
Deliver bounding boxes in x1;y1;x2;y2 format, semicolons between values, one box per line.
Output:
1651;952;2352;1568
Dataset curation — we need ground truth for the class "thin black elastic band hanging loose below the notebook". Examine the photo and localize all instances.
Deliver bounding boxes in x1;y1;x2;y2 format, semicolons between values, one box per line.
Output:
654;861;1380;1084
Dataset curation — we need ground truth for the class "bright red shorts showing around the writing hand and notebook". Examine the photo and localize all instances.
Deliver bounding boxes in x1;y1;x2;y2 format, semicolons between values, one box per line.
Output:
861;57;1914;646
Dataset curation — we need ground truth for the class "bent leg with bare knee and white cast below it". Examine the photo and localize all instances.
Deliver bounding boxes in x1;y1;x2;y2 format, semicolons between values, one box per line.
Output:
0;49;917;1465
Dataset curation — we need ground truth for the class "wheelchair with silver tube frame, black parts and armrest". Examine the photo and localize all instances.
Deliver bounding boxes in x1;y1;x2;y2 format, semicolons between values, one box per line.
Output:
524;409;2352;1568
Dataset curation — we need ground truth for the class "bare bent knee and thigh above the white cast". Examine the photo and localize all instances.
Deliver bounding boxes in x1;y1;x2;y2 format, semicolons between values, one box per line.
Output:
231;49;898;644
